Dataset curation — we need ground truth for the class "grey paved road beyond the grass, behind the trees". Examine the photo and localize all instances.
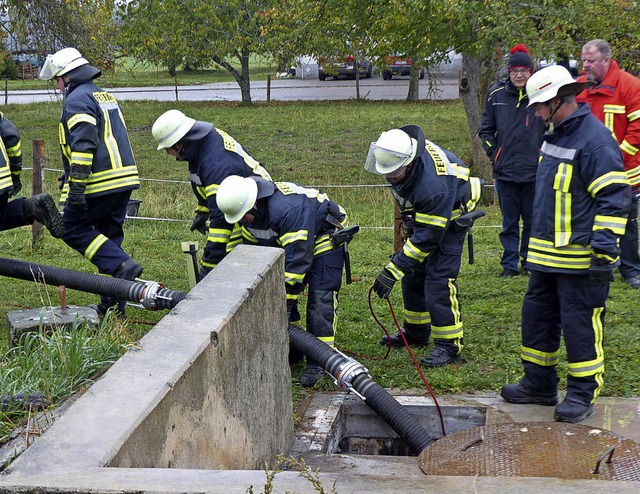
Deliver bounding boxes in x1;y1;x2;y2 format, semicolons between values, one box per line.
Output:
0;74;458;104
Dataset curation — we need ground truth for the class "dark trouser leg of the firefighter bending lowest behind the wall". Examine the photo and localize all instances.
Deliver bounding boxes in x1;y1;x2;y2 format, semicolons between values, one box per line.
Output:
306;248;344;347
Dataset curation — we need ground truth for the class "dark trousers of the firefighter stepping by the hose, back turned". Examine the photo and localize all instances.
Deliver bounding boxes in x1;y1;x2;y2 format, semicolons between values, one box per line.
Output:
63;191;131;275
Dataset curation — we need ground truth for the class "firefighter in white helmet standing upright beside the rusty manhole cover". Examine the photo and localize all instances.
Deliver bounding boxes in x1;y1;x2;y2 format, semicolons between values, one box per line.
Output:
501;65;631;422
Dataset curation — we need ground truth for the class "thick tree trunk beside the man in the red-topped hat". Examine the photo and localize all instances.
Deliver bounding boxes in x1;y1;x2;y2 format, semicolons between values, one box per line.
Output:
458;53;492;199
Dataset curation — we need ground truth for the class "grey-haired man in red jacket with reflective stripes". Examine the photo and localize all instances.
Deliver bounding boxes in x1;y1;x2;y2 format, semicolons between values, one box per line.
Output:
576;39;640;289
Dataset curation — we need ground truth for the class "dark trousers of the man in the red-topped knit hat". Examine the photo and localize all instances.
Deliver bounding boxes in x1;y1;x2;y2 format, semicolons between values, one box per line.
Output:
495;180;535;271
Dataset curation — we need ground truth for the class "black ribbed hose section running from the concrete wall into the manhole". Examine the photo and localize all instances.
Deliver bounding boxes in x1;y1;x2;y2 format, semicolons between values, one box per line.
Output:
289;324;435;455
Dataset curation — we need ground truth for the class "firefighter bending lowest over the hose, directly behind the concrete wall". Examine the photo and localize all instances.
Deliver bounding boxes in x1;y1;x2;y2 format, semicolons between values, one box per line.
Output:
217;176;347;387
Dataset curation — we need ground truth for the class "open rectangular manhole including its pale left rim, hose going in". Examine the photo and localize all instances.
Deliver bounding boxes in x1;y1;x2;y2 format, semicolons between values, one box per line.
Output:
294;395;487;456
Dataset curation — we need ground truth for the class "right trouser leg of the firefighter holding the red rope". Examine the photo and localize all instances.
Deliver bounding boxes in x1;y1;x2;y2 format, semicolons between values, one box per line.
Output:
422;225;467;353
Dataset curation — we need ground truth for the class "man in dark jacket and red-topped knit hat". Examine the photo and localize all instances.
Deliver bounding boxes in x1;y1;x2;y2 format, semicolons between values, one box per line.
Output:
478;45;544;277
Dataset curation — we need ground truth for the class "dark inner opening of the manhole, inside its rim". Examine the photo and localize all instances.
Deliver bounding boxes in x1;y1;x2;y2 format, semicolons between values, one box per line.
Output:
326;401;487;456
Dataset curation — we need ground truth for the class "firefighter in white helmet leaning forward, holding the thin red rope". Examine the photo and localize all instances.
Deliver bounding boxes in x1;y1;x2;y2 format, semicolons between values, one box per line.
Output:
365;125;481;367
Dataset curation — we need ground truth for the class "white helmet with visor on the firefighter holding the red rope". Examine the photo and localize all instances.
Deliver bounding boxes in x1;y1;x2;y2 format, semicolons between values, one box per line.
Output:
365;129;418;175
